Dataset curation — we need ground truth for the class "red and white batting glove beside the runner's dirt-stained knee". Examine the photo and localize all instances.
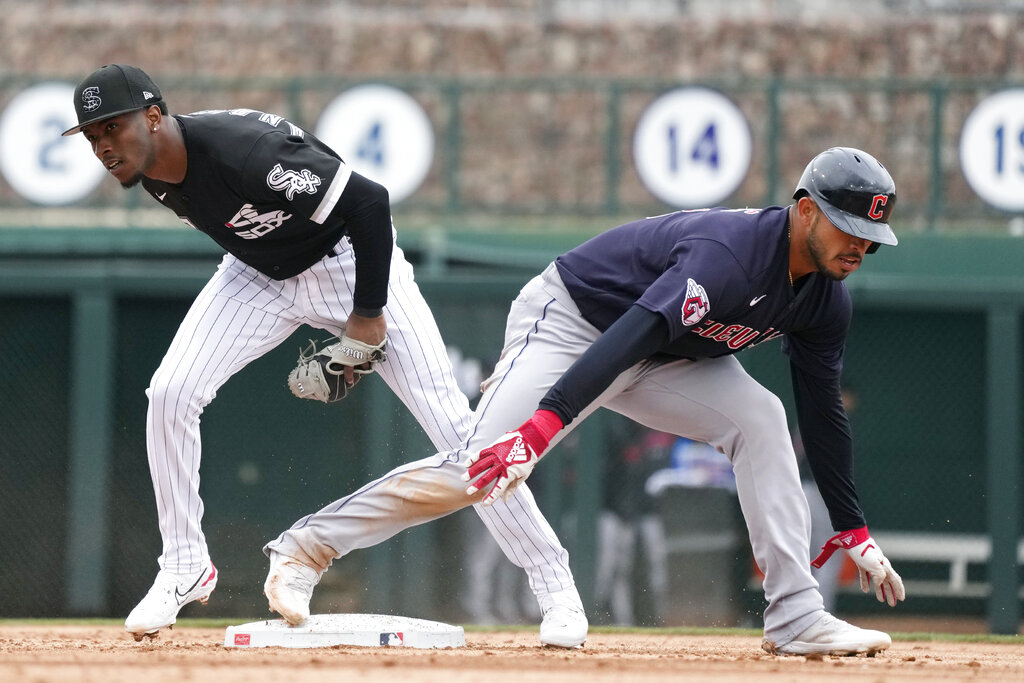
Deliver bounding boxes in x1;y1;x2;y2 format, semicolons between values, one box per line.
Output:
462;411;564;505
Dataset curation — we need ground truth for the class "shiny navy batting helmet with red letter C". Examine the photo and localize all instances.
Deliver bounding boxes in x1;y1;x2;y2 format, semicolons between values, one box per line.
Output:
793;147;898;254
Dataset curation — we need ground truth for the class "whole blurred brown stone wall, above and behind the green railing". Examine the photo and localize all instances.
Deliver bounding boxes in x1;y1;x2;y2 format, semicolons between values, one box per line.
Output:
0;0;1024;229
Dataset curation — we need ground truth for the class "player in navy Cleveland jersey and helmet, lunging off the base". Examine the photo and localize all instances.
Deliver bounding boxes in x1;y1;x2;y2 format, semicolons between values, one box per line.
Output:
271;147;904;654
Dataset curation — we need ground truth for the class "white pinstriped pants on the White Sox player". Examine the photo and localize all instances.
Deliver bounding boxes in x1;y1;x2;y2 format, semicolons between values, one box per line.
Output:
146;232;573;592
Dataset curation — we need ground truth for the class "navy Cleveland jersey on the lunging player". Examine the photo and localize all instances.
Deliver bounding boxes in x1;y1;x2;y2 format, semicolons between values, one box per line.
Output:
556;207;852;377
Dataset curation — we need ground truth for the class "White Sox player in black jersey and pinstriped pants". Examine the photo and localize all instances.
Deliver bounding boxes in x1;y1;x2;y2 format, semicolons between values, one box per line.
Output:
65;65;587;646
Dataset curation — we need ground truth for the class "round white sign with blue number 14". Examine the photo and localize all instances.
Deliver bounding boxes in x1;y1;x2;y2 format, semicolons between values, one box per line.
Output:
633;87;751;209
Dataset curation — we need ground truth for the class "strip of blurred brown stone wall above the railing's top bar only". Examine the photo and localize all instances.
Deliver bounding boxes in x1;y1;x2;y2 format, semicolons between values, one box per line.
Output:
9;0;1024;79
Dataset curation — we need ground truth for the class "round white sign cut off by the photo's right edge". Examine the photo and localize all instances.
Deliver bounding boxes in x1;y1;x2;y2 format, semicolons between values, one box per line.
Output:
959;89;1024;211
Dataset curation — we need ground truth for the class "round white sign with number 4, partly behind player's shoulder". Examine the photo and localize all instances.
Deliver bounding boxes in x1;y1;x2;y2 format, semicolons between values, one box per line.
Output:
315;84;434;203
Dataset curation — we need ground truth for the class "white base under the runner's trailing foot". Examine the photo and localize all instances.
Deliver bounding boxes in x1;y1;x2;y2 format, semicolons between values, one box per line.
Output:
224;614;466;649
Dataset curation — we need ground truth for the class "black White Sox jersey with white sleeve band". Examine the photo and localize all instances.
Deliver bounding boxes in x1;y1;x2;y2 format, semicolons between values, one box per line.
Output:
142;110;392;309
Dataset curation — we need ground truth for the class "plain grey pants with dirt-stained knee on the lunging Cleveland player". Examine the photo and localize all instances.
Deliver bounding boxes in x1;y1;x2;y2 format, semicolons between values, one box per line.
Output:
268;265;823;645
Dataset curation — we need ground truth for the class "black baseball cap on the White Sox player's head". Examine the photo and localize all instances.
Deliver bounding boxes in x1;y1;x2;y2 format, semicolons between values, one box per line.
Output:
62;65;163;135
